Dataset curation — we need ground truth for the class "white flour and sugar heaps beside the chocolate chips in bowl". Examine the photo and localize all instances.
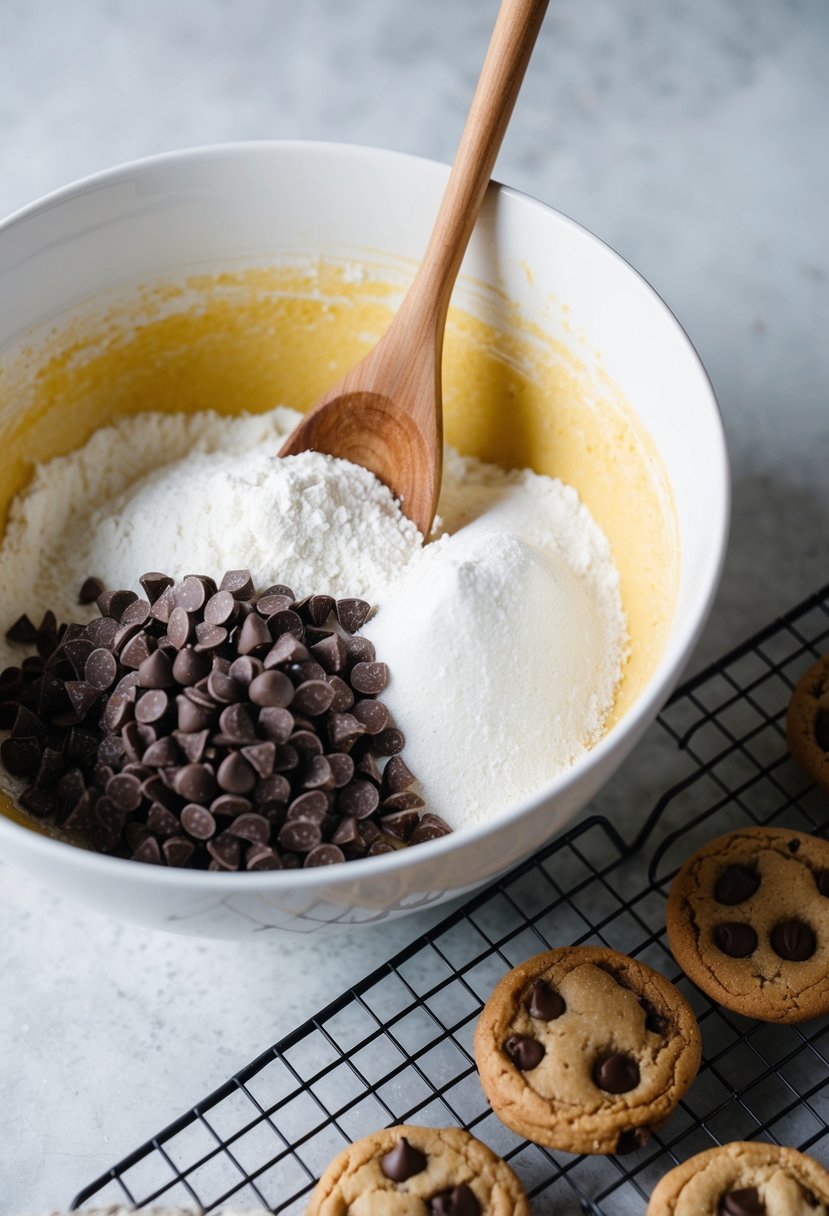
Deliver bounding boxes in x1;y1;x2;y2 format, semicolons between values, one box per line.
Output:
0;409;626;860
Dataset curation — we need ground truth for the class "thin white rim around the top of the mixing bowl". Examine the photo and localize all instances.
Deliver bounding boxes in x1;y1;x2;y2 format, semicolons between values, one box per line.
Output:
0;139;732;894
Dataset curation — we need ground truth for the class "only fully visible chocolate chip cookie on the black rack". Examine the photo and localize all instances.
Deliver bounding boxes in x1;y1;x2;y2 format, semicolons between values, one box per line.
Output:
475;946;700;1153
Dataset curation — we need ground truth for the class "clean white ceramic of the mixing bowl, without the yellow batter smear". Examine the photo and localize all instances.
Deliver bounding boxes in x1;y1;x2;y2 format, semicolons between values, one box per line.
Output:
0;142;728;936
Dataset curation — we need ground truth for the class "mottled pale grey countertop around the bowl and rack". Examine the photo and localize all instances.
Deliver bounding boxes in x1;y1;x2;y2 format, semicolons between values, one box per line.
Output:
0;0;829;1212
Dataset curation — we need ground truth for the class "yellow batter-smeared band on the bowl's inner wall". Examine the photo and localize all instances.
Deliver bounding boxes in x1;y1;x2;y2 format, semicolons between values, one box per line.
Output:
0;258;678;817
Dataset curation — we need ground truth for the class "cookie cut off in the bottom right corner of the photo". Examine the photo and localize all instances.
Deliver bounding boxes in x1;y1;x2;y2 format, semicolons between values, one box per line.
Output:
648;1142;829;1216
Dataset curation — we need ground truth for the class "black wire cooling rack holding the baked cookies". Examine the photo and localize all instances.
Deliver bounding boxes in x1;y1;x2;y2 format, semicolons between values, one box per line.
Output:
73;586;829;1216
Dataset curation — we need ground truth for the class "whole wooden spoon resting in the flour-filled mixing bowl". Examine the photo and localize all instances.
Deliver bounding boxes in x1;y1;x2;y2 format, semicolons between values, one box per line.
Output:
280;0;547;536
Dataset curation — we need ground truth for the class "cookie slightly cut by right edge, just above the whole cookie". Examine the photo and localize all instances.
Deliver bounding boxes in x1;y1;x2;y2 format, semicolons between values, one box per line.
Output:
667;828;829;1021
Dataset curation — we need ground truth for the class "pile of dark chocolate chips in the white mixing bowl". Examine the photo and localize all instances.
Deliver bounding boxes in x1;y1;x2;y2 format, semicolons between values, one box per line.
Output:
0;570;450;871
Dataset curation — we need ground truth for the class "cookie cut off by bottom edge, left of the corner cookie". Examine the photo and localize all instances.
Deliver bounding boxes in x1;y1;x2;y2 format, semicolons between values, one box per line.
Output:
306;1125;530;1216
